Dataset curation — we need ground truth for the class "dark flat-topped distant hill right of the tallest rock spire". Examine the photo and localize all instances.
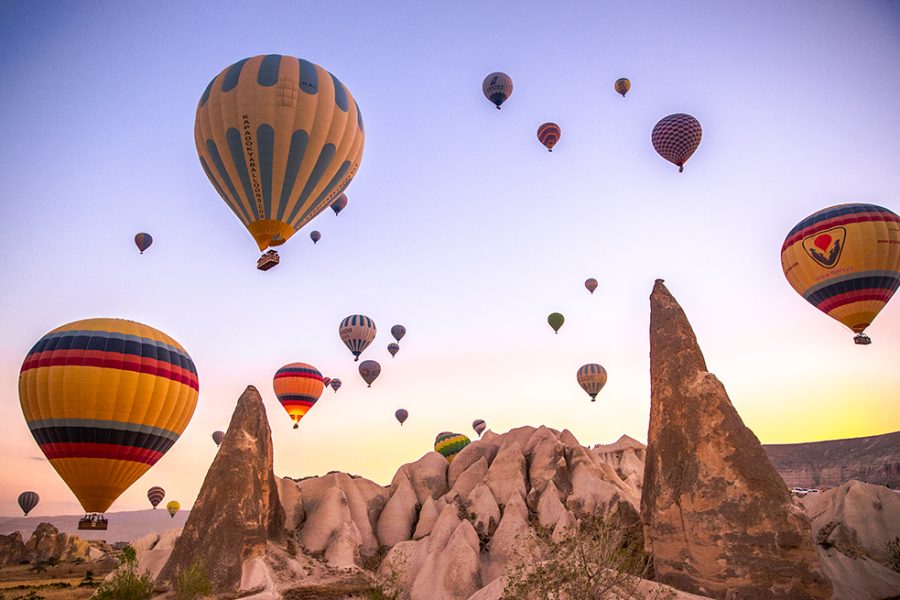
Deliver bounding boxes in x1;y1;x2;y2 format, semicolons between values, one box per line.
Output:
763;431;900;489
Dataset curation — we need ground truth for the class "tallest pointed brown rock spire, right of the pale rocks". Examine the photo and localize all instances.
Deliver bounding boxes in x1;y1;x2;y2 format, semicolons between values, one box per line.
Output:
641;280;831;600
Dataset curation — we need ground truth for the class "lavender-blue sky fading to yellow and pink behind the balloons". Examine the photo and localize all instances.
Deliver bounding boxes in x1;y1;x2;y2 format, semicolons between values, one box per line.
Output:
0;0;900;515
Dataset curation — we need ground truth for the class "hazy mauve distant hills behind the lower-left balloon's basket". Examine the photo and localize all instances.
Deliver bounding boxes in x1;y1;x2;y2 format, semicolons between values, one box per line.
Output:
0;509;190;544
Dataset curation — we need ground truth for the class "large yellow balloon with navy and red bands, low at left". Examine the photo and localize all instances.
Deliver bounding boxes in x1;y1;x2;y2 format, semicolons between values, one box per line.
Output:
19;319;199;529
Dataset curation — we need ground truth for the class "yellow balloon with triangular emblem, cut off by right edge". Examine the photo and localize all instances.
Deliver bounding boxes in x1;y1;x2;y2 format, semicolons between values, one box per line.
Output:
781;204;900;345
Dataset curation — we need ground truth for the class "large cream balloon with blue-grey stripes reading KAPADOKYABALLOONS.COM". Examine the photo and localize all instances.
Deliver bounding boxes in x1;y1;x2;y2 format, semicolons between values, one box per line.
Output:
194;54;365;270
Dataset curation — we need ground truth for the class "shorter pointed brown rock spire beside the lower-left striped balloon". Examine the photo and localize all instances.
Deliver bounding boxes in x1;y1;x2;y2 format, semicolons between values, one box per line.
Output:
158;386;285;591
